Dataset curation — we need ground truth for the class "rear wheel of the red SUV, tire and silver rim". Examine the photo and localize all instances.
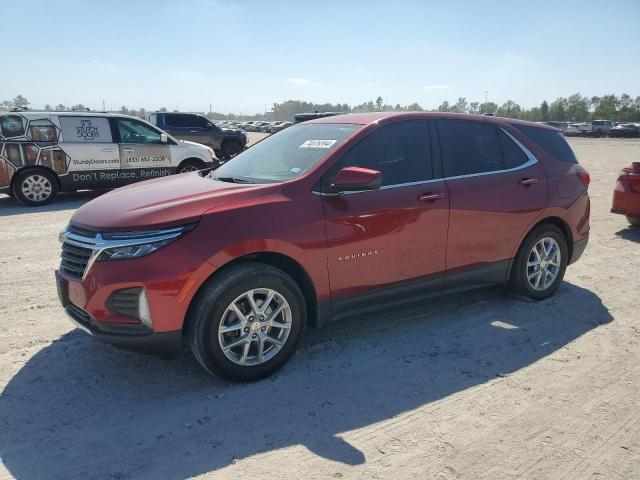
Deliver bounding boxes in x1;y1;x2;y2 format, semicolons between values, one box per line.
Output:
509;225;569;300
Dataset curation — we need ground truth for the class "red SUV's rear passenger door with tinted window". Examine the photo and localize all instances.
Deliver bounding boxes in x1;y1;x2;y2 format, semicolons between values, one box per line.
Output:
438;120;547;287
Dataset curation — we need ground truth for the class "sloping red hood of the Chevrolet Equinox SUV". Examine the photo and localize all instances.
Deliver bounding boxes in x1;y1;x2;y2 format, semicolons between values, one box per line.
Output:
71;172;278;232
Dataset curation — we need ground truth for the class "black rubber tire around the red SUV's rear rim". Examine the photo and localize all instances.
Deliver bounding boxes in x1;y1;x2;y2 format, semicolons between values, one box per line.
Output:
509;224;569;301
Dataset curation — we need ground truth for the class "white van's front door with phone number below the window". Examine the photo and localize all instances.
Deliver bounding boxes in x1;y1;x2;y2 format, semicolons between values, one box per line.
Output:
111;117;175;185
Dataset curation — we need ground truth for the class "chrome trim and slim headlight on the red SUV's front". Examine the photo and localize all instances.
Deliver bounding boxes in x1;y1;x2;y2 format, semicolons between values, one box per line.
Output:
58;227;184;280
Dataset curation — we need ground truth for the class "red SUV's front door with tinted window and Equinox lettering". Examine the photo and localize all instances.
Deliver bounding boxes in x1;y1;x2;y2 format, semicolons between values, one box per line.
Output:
322;121;449;315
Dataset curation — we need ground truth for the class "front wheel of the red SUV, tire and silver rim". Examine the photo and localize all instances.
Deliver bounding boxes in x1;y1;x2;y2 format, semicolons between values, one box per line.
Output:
189;263;306;381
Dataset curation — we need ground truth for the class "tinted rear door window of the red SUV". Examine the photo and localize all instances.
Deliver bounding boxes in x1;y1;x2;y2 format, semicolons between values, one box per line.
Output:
438;120;505;177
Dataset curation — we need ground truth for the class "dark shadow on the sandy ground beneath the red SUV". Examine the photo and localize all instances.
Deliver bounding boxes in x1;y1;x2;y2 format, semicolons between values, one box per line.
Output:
0;282;612;479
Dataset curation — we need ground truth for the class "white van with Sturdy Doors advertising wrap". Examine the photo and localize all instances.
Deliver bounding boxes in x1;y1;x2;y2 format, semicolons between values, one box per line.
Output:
0;111;219;205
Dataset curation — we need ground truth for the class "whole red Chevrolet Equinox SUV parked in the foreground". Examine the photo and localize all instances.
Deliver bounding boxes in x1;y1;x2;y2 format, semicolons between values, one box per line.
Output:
56;113;589;380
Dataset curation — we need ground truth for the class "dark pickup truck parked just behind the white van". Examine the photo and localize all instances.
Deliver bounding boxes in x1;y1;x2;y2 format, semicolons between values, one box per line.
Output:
149;112;247;160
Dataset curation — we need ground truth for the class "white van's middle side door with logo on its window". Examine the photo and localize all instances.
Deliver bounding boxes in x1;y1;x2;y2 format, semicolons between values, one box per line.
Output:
56;115;120;190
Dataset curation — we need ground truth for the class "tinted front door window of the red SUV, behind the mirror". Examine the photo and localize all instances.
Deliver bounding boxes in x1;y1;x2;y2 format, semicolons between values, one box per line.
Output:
334;122;433;186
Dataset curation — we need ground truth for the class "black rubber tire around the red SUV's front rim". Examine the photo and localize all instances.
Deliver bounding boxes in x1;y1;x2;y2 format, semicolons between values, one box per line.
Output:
188;263;307;382
